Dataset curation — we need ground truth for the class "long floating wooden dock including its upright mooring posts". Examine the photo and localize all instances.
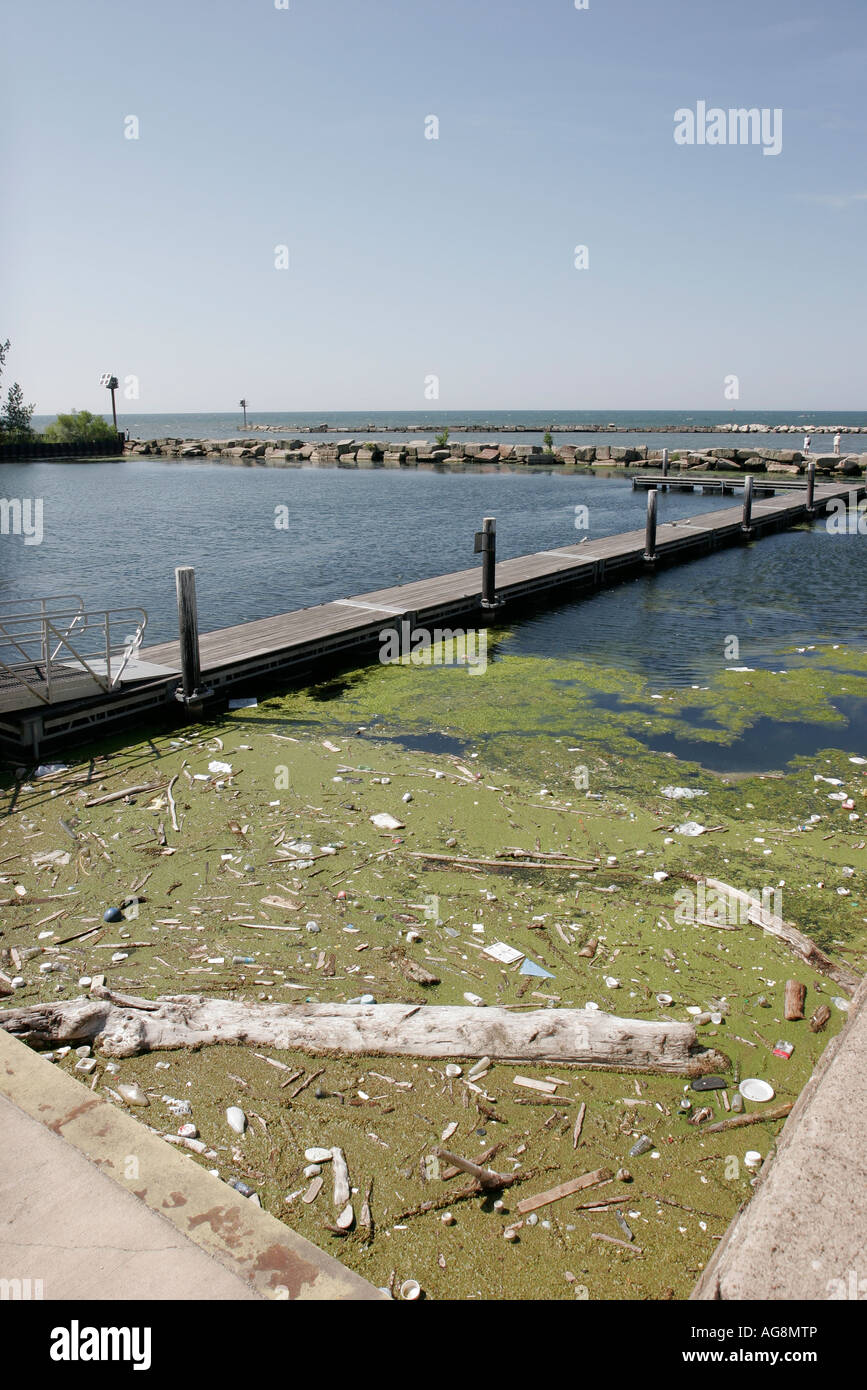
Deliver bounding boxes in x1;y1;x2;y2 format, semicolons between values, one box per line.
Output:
0;478;867;760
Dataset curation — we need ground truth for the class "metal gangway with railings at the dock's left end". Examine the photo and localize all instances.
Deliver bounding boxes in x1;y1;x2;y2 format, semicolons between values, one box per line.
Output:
0;594;147;710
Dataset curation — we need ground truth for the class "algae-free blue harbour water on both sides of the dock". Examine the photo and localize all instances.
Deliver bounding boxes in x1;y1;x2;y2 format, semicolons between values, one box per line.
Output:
0;460;867;687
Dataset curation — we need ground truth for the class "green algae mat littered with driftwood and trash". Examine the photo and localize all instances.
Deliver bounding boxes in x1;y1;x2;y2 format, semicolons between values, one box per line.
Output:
0;648;867;1300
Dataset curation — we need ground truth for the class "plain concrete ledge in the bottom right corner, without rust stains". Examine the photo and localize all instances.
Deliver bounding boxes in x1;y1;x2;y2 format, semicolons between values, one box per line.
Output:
691;981;867;1300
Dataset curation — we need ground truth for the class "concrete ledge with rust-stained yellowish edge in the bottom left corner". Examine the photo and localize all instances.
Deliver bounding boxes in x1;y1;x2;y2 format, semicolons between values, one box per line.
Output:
0;1029;386;1301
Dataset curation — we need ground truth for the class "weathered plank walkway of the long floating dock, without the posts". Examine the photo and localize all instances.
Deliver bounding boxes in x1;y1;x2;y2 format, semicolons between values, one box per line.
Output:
0;480;866;751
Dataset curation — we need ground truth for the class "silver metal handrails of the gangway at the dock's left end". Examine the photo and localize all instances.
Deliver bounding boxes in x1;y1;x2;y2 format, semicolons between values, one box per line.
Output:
0;606;147;705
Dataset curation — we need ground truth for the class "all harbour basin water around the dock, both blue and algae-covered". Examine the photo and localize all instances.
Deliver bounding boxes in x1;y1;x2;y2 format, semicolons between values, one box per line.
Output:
0;464;867;1300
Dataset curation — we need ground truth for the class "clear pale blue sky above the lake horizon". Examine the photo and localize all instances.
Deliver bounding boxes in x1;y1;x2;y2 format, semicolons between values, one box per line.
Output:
0;0;867;413
